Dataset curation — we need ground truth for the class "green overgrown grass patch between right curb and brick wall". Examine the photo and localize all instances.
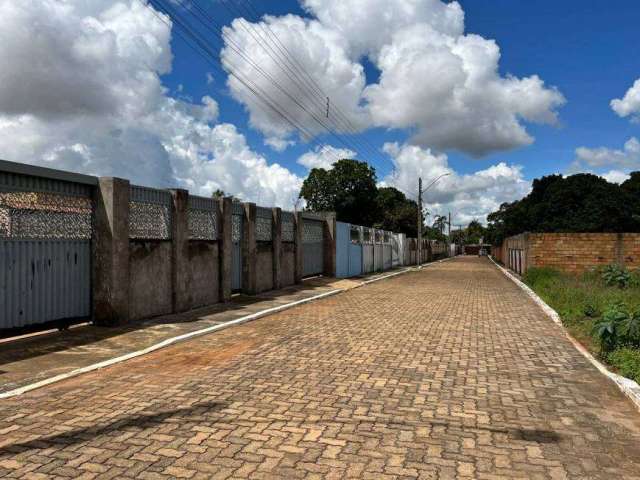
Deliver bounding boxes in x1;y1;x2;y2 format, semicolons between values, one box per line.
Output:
524;268;640;382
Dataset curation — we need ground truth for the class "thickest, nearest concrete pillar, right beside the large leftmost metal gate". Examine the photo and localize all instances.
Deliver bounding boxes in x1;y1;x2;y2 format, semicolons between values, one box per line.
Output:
93;177;130;325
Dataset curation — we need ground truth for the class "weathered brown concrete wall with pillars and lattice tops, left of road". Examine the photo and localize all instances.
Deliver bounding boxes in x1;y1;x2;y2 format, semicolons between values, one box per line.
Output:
92;178;402;325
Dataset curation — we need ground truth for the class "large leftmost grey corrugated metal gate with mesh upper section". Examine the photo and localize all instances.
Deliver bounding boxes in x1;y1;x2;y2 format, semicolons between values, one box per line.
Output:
0;162;97;329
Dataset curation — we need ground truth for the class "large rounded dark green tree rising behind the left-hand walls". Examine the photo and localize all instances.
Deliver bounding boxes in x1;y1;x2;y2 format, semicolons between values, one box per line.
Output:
300;159;380;225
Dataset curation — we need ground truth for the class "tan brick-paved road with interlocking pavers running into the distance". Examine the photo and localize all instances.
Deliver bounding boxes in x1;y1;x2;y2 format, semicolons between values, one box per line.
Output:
0;258;640;479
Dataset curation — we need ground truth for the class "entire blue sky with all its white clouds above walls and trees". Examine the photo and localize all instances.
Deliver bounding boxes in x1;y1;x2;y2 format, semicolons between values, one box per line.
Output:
0;0;640;224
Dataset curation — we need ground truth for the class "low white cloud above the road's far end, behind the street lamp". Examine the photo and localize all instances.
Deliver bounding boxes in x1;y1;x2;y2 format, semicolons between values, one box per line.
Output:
382;143;531;225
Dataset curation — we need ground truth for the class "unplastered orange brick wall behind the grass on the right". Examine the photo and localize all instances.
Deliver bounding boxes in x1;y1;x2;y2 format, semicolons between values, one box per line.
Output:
494;233;640;273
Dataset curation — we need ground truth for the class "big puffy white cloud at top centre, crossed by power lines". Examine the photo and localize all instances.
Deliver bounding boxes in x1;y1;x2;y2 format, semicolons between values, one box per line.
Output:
223;0;565;156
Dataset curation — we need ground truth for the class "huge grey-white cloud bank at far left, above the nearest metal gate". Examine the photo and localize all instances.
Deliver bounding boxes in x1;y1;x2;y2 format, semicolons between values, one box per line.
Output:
0;0;301;208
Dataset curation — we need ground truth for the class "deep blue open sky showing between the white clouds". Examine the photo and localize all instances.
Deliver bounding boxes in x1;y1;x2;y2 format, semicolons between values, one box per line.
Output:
164;0;640;180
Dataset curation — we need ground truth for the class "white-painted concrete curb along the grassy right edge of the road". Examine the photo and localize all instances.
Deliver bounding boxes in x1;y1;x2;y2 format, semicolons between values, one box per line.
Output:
489;257;640;411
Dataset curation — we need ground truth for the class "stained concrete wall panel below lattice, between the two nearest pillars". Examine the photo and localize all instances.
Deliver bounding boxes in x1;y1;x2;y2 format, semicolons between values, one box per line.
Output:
128;241;172;320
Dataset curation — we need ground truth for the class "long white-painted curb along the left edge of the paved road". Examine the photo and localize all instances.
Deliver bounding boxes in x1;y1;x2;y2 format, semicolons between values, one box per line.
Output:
0;258;458;400
